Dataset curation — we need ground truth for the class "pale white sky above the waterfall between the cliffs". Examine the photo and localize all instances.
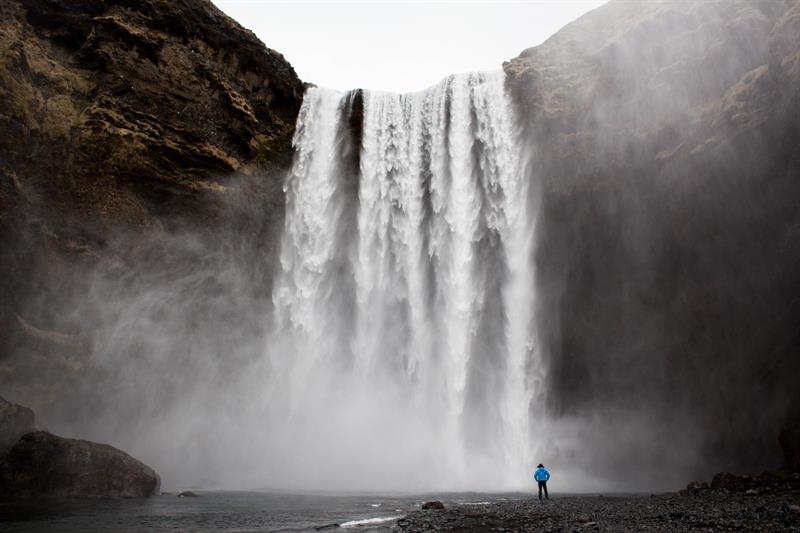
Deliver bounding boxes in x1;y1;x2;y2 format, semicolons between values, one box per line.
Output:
213;0;604;92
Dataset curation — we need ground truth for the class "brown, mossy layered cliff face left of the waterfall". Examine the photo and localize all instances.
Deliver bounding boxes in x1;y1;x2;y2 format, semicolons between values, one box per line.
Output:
0;0;303;419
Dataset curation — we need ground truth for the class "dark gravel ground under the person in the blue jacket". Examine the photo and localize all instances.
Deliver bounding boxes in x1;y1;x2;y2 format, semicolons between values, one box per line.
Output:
395;480;800;532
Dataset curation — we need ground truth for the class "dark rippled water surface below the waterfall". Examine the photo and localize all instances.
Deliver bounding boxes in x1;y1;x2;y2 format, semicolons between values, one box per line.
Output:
0;491;529;533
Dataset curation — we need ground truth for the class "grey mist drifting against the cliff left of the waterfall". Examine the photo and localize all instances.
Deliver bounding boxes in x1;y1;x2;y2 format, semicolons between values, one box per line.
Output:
4;177;282;487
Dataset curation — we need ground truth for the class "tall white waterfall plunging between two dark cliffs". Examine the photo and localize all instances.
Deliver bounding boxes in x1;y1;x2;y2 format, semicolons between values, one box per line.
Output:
265;72;538;490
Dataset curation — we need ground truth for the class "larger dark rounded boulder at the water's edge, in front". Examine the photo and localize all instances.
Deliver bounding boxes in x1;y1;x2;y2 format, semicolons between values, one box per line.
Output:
0;431;161;499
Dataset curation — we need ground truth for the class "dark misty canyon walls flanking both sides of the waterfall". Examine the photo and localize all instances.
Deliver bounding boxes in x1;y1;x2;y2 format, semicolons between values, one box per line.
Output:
0;0;800;488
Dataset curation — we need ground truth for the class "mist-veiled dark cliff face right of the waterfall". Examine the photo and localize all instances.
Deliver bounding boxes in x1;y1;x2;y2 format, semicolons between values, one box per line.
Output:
504;1;800;485
